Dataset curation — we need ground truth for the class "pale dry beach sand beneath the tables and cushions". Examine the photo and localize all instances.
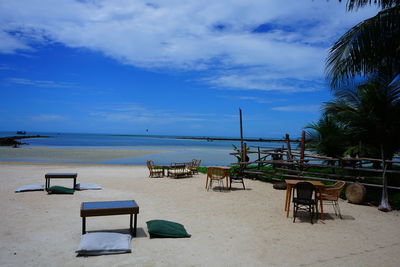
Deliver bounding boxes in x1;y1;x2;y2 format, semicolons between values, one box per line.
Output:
0;162;400;266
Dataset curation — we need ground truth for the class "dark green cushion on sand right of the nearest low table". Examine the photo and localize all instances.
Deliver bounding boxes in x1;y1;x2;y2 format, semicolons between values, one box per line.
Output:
146;220;191;238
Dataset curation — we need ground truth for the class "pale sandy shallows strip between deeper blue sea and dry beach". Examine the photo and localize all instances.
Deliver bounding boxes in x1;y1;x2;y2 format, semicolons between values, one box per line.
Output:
0;146;236;166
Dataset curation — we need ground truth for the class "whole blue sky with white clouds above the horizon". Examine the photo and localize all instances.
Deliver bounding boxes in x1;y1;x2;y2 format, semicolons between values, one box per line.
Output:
0;0;377;138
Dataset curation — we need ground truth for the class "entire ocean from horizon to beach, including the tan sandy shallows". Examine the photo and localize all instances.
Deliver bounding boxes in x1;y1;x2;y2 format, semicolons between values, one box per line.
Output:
0;132;282;166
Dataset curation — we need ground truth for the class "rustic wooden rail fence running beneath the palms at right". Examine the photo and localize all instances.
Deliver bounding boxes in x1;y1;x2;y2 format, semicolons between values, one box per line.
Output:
231;135;400;190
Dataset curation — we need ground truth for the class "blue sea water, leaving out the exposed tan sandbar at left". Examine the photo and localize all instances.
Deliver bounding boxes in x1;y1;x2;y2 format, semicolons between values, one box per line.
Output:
0;132;281;166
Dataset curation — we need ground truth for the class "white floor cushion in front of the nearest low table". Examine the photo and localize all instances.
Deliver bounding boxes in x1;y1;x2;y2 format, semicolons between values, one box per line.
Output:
75;232;131;256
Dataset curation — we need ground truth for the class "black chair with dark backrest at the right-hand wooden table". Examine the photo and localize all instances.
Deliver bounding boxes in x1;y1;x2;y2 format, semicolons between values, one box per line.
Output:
293;182;318;224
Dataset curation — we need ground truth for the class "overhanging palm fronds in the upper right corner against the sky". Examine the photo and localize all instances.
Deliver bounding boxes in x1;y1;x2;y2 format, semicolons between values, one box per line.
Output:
326;0;400;89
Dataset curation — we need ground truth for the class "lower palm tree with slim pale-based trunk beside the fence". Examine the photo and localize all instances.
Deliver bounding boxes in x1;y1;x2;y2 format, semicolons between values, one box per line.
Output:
325;79;400;211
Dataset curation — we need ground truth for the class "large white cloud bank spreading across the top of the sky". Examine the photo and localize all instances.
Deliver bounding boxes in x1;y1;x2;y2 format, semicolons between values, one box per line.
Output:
0;0;376;92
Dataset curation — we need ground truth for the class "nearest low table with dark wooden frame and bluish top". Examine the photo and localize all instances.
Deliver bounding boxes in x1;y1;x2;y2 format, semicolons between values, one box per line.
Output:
81;200;139;236
